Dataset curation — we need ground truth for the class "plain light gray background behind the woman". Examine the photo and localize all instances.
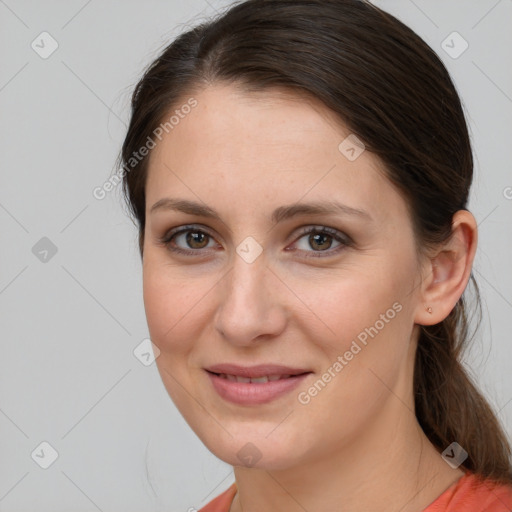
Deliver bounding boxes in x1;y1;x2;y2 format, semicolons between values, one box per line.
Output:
0;0;512;512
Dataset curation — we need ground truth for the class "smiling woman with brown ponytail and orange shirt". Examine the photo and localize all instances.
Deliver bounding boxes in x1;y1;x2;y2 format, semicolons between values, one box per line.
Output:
121;0;512;512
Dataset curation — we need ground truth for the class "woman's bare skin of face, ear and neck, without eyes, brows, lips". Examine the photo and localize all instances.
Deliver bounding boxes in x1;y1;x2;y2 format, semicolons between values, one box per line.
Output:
143;84;477;512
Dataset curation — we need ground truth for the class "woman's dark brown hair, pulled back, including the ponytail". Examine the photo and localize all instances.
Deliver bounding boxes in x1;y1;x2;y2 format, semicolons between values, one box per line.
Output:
120;0;512;483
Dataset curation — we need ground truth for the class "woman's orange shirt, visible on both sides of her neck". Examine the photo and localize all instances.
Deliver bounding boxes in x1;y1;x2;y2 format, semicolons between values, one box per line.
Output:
199;471;512;512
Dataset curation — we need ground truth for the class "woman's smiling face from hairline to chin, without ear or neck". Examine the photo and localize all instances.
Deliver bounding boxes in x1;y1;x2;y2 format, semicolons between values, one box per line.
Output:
143;85;424;469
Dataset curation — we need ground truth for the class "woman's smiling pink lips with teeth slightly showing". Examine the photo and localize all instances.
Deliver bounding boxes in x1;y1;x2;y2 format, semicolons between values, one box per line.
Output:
205;365;313;406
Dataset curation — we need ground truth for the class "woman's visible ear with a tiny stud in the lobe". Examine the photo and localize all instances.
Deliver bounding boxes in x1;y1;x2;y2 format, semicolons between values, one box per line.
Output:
415;210;478;325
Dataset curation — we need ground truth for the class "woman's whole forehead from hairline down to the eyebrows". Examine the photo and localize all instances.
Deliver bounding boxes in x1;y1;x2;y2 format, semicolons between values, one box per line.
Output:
146;85;403;224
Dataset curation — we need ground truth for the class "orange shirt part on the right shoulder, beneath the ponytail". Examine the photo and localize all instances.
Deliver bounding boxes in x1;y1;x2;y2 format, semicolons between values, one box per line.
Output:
424;472;512;512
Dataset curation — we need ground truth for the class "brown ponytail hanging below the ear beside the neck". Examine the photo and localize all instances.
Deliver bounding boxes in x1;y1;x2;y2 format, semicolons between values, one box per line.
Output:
414;276;512;484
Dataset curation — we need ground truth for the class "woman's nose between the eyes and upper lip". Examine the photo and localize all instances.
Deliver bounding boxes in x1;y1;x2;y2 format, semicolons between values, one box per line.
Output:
215;250;287;346
